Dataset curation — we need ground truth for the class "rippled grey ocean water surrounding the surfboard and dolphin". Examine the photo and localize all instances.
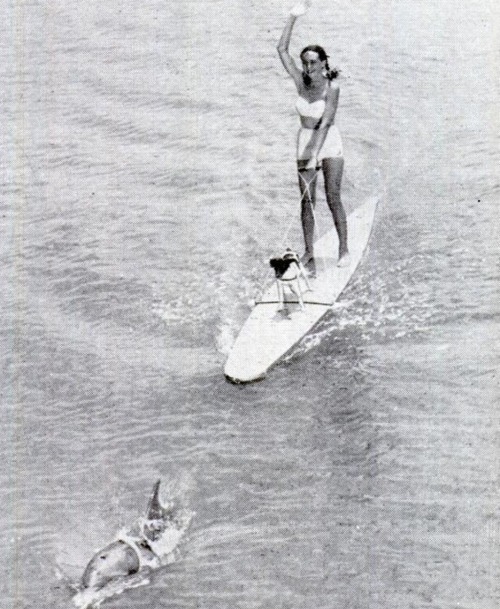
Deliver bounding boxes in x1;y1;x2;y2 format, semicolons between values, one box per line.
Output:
0;0;500;609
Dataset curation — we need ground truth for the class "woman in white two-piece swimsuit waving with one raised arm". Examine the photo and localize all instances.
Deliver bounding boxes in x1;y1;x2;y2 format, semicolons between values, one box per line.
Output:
278;0;350;273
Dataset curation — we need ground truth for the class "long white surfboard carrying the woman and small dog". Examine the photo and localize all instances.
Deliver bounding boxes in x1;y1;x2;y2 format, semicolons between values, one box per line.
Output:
224;198;377;383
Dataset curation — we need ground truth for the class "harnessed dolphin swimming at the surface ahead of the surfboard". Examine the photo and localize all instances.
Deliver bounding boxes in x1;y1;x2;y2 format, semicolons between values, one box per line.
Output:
80;480;184;592
